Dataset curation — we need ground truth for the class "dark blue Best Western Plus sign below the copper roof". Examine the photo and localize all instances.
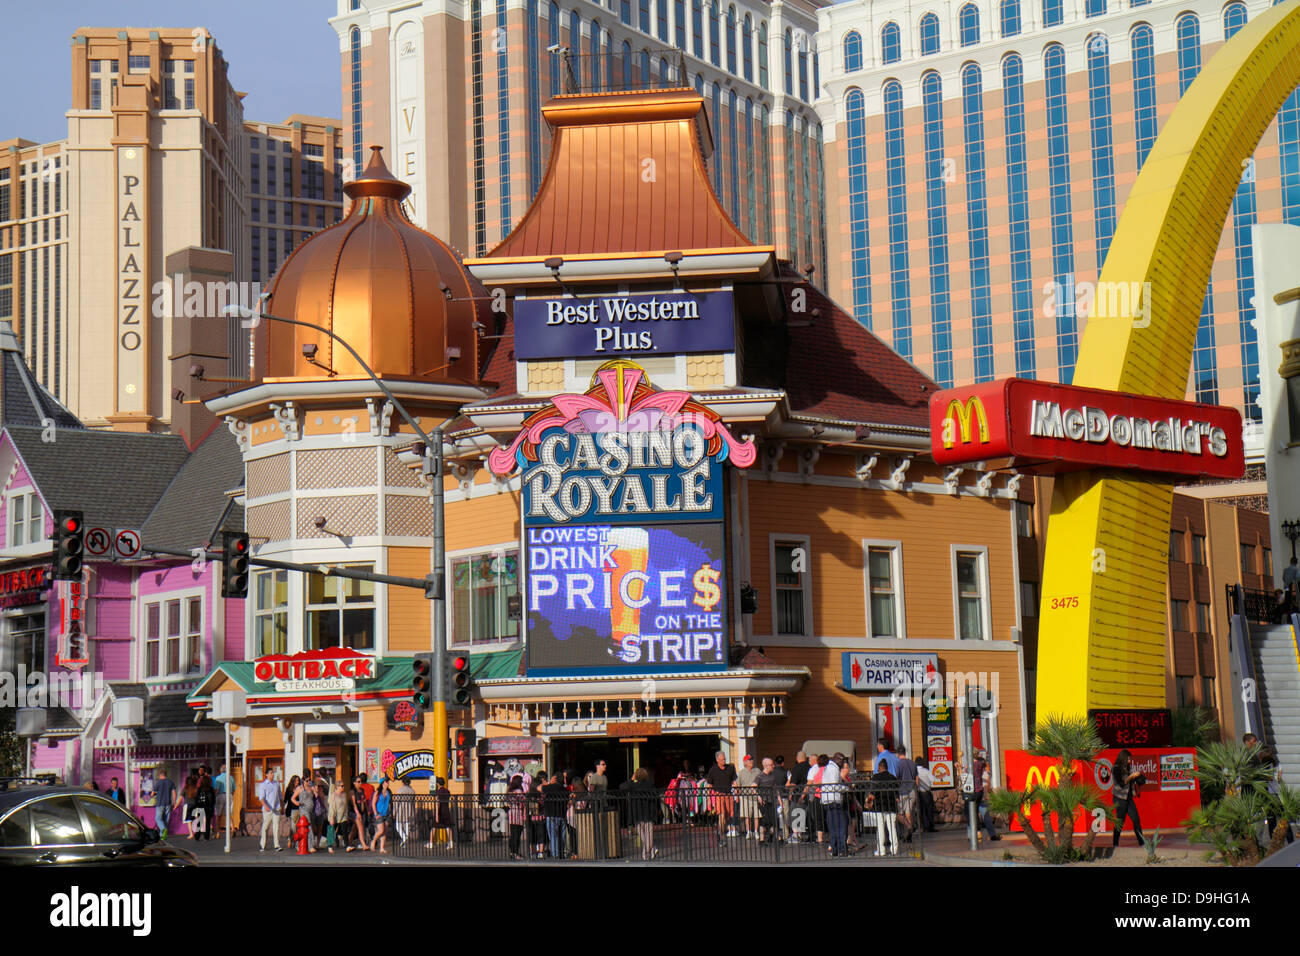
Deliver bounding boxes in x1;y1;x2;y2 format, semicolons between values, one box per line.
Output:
514;291;736;362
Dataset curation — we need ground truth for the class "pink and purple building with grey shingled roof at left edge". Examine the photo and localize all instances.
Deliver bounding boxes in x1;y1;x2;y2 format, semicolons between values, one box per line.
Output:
0;324;244;830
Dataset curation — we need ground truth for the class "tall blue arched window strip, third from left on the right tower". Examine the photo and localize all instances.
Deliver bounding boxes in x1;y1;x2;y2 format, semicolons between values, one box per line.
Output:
920;70;953;388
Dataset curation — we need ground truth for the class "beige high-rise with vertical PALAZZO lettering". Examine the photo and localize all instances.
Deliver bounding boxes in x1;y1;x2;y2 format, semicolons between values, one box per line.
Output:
0;27;342;442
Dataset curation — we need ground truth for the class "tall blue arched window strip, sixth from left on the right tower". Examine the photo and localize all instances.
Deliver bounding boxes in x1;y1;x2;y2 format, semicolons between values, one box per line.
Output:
1043;43;1079;385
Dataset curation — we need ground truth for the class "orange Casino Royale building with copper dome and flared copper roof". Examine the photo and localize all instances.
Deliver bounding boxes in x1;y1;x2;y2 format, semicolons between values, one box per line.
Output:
189;90;1034;792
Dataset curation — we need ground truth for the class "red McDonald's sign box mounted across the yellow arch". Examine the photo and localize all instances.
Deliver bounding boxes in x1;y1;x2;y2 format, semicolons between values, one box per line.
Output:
930;378;1245;479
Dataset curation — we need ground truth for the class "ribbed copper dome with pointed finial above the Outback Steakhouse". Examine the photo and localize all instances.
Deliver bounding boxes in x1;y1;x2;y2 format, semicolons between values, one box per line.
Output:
254;146;488;382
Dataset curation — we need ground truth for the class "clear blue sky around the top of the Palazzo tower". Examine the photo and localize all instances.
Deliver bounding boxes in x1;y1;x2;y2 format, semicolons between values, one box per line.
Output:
0;0;342;143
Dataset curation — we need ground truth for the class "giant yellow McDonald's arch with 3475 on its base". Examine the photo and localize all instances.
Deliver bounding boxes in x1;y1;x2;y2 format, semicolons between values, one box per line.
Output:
1037;0;1300;714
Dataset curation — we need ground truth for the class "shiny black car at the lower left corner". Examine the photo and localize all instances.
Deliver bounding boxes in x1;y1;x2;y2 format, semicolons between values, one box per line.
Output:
0;786;198;866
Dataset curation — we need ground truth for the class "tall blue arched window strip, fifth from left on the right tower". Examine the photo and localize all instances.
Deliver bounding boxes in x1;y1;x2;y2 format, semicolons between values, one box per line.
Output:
1002;53;1037;378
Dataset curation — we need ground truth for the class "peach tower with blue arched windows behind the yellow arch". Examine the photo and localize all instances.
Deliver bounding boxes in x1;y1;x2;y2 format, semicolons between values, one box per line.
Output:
818;0;1284;447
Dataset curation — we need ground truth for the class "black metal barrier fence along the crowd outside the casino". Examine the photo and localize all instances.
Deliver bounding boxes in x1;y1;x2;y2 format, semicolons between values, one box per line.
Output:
335;780;924;864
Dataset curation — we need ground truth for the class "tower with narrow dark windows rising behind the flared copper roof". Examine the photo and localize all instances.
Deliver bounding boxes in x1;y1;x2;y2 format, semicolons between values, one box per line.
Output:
330;0;827;274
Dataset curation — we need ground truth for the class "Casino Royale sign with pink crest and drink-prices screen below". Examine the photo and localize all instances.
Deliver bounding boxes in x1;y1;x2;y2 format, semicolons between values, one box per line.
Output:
489;360;755;674
